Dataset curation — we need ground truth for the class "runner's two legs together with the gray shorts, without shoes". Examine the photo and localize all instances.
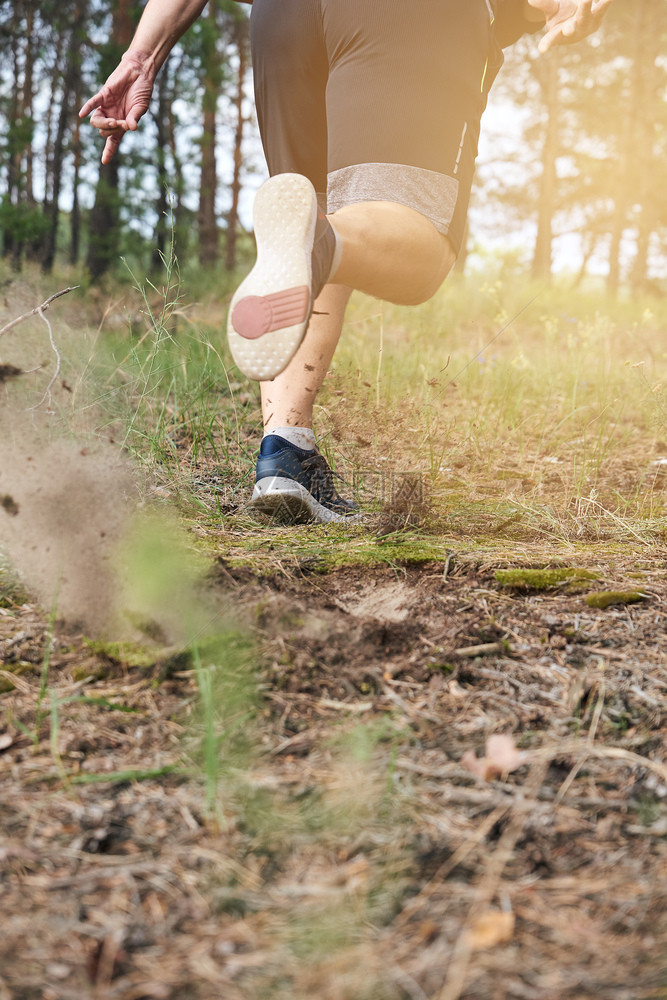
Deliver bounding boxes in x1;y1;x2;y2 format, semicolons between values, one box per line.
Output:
245;0;490;524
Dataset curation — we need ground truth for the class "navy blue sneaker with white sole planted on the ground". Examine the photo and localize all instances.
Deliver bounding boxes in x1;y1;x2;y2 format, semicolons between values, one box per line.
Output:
248;434;361;524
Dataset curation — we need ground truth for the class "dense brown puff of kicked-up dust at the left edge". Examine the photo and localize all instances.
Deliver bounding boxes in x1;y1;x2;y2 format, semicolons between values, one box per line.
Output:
0;420;137;634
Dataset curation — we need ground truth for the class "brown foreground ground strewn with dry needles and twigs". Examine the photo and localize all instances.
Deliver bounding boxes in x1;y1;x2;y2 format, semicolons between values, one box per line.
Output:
0;551;667;1000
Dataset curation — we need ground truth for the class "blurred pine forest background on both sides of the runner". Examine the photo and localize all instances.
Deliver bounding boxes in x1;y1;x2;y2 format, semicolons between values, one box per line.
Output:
0;0;667;294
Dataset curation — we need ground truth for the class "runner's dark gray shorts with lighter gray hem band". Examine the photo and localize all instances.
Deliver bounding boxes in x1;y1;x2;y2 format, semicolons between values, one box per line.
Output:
251;0;502;252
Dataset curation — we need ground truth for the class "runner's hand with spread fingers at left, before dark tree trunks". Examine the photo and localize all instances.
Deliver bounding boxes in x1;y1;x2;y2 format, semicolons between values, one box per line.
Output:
79;52;155;164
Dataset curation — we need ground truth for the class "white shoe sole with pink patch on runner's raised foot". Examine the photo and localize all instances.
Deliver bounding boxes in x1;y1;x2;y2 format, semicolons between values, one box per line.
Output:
227;174;317;381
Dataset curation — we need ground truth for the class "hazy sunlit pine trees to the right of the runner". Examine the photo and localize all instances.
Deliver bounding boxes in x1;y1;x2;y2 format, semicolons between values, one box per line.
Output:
486;0;667;292
